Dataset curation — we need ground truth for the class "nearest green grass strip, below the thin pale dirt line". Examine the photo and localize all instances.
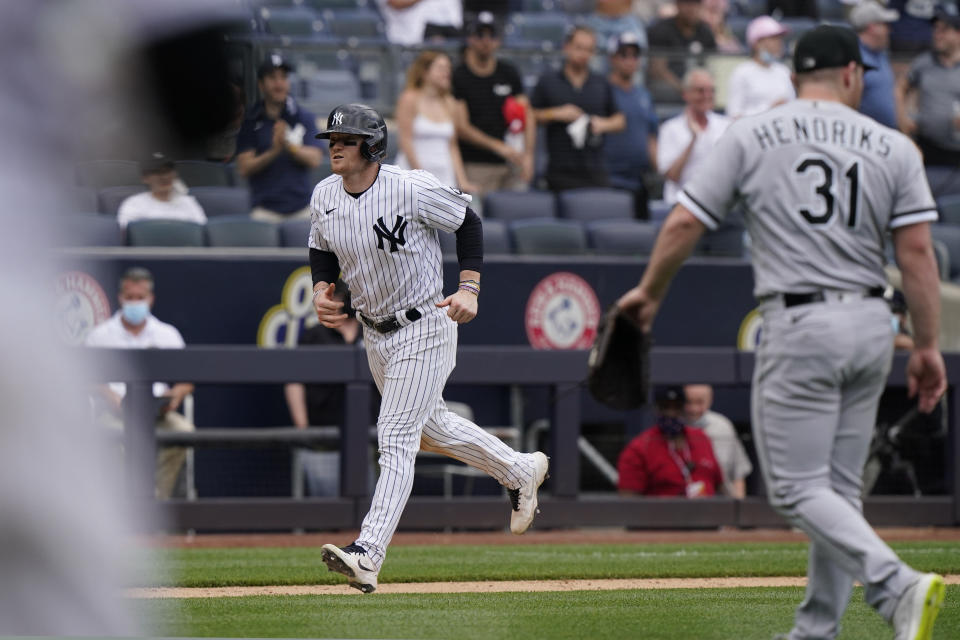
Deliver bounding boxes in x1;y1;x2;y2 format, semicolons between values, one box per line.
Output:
136;588;960;640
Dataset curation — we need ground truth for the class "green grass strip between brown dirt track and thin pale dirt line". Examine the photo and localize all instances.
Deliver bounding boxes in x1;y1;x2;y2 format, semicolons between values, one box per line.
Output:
138;541;960;584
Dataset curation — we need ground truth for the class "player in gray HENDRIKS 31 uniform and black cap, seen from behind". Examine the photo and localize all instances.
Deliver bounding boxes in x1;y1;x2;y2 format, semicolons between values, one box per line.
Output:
618;26;946;640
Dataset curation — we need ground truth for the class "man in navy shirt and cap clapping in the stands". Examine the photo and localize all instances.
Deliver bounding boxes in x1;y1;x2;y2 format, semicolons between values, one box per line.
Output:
237;53;323;222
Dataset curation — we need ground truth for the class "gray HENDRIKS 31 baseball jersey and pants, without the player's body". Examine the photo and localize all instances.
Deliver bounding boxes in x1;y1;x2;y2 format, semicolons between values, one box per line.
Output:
679;100;937;640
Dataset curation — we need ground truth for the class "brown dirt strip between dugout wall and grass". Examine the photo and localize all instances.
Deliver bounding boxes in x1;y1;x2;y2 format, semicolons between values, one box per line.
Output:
142;527;960;549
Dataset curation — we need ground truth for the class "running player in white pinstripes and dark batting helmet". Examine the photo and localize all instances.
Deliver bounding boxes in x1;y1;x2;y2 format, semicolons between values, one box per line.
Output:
308;104;548;593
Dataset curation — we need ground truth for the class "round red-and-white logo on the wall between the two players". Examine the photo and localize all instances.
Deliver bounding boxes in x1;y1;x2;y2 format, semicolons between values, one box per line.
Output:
525;272;600;349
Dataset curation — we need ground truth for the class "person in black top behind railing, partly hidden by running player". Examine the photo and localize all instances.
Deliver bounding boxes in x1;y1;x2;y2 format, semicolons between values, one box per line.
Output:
284;281;364;496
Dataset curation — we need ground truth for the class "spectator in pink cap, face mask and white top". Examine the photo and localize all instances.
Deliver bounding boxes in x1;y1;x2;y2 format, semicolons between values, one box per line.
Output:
727;16;797;118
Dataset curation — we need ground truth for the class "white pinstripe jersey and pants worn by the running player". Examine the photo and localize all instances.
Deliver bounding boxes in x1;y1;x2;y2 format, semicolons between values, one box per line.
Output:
309;165;542;590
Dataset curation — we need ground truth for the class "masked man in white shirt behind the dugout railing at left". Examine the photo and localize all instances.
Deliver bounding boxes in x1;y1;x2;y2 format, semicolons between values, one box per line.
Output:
86;267;194;500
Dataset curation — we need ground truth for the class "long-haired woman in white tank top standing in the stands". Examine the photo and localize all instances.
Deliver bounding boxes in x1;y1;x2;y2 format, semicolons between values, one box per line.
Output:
396;51;476;192
